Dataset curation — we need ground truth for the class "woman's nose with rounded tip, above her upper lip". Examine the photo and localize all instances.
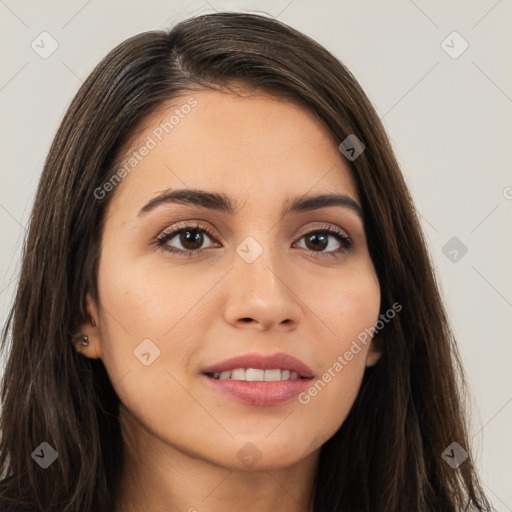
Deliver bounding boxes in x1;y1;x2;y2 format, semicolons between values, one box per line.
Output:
224;243;303;331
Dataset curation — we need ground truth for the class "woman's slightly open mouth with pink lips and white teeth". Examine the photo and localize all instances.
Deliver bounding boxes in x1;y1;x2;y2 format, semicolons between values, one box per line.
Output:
202;353;314;406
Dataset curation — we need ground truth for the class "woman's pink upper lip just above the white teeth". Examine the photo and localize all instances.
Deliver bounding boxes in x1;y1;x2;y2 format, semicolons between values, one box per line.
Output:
203;352;313;378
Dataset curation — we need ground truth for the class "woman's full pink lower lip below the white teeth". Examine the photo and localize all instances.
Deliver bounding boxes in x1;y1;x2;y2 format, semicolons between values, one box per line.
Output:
205;376;311;405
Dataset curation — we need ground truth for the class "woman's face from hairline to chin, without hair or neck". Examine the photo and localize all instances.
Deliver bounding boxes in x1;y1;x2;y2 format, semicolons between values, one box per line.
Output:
84;87;380;468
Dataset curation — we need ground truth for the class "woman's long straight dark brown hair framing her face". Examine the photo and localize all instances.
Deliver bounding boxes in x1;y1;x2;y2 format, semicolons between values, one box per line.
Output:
0;12;490;512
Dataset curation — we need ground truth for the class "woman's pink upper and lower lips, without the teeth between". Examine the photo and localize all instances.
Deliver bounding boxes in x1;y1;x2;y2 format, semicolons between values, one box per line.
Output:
202;353;314;406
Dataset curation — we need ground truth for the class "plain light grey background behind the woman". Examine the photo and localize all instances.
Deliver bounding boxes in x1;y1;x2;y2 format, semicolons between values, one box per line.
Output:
0;0;512;511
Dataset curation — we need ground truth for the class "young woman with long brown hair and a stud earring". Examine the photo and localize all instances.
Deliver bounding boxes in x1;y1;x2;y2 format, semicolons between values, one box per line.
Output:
0;13;490;512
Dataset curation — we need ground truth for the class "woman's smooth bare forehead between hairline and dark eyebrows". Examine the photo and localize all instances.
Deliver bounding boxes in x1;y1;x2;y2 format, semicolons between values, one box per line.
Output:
107;91;358;213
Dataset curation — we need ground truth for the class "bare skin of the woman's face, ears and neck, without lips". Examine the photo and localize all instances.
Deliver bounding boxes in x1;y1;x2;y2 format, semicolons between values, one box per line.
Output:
76;91;380;512
